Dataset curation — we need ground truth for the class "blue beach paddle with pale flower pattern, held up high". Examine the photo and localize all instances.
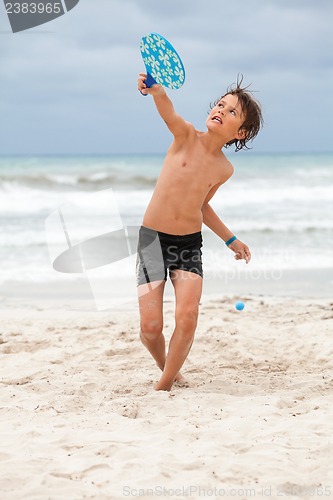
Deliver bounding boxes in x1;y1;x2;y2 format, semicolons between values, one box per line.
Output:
140;33;185;95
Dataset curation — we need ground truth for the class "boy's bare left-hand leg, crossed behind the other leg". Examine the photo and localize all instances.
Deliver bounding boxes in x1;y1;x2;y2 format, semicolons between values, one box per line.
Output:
138;280;166;370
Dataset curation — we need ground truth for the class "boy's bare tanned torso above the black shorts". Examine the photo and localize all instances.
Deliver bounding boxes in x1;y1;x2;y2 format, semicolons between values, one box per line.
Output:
143;131;230;234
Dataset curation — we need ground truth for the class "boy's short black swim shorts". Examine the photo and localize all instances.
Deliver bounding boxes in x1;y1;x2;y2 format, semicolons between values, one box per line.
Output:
136;226;203;285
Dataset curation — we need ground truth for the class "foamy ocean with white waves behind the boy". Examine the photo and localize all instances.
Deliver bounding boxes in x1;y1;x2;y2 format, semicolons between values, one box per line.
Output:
0;152;333;300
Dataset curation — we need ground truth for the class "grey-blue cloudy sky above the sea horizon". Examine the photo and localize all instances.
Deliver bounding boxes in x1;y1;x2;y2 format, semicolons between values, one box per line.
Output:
0;0;333;154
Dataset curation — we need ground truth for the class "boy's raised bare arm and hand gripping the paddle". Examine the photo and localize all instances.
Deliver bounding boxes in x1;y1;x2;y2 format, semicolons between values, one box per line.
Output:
138;73;191;137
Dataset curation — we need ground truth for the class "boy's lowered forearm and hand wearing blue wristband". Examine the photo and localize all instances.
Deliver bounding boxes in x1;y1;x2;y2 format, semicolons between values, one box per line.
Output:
201;201;251;264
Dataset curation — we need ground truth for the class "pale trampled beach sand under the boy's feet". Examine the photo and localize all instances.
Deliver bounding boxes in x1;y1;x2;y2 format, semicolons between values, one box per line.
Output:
0;296;333;500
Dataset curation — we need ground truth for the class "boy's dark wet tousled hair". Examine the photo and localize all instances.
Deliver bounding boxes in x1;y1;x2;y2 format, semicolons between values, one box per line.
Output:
210;75;264;151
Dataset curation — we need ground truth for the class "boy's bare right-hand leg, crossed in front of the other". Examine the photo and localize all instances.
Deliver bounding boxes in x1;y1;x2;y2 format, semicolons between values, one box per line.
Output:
155;269;202;391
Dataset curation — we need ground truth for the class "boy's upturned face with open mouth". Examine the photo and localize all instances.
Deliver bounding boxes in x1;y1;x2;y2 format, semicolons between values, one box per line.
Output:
206;94;245;142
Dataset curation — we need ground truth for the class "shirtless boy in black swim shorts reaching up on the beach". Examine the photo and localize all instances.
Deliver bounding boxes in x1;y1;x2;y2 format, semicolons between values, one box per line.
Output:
137;73;262;391
